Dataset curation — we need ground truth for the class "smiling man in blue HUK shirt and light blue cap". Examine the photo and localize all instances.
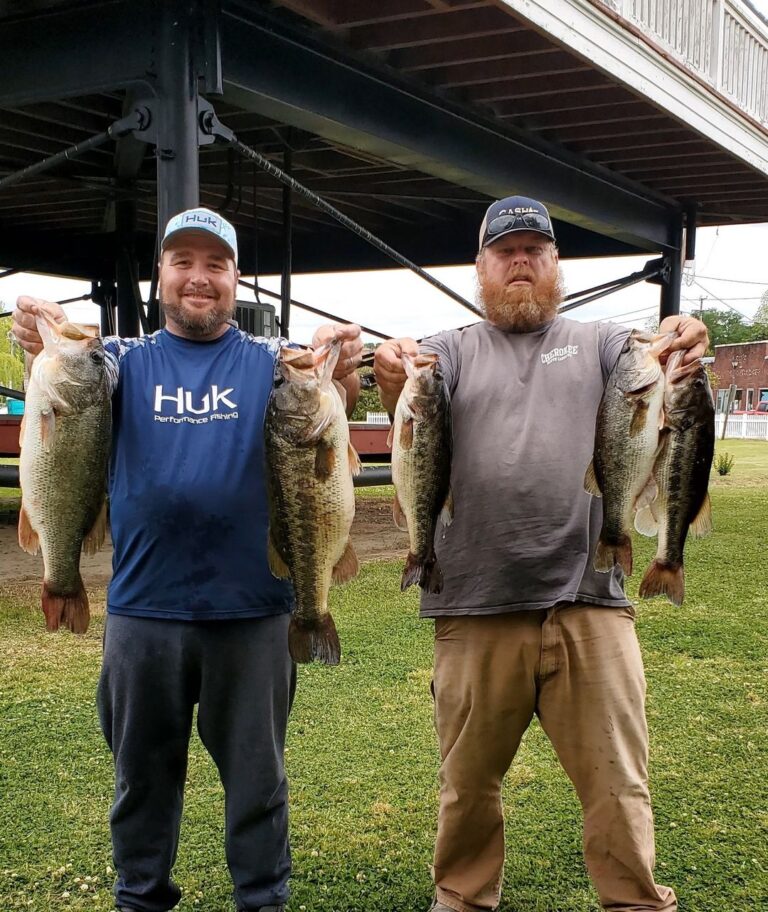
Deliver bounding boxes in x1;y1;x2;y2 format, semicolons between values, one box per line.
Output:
14;209;362;912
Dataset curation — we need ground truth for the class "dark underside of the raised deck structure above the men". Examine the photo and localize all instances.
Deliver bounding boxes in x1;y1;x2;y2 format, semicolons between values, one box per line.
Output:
0;0;768;290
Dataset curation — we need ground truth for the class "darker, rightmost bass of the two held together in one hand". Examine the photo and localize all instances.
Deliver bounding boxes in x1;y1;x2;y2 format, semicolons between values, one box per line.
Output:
635;351;715;605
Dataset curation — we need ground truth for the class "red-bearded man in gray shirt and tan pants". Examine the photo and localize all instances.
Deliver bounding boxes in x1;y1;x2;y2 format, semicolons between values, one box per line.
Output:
375;196;708;912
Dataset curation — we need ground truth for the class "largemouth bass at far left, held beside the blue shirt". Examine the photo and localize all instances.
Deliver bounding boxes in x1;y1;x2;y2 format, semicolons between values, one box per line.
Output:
19;315;112;633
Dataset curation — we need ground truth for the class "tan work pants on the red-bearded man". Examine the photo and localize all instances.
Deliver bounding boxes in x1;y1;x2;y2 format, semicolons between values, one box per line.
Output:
434;603;677;912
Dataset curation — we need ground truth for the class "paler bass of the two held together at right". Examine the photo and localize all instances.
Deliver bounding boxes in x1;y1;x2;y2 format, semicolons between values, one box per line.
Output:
584;330;675;576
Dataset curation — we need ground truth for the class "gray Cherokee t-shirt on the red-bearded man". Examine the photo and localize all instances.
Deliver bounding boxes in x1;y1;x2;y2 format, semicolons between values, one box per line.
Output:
421;317;629;617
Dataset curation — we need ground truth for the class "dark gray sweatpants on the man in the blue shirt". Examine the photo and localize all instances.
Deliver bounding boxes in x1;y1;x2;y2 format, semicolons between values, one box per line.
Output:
97;614;296;912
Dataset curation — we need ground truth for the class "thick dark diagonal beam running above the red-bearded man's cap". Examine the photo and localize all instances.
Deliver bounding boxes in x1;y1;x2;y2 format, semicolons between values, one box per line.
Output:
221;9;674;250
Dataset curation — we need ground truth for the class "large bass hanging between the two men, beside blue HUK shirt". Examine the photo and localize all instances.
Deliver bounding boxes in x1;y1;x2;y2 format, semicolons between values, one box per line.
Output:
265;340;360;665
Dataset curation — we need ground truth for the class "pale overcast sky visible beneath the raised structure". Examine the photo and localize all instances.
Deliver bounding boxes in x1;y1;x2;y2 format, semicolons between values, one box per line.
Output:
0;0;768;342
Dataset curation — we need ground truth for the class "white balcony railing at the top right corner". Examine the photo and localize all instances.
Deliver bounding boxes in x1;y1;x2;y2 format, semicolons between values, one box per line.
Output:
603;0;768;124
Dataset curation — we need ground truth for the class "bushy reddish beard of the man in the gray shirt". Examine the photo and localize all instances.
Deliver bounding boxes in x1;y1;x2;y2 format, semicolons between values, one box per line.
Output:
476;269;565;332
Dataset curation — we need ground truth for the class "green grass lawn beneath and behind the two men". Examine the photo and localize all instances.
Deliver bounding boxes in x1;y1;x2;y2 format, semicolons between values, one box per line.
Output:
0;441;768;912
